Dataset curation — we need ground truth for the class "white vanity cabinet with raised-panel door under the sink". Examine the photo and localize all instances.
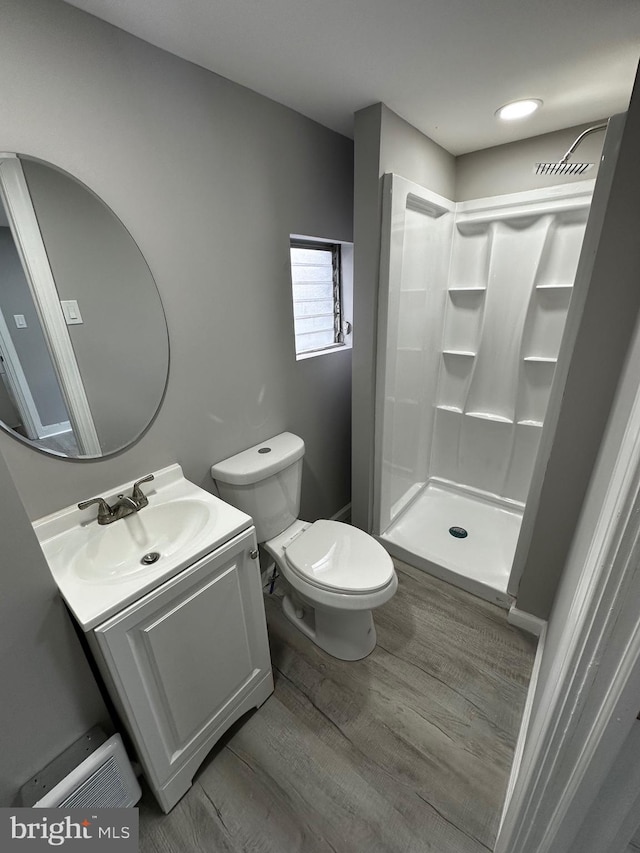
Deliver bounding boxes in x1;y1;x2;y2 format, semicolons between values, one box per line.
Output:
87;527;273;811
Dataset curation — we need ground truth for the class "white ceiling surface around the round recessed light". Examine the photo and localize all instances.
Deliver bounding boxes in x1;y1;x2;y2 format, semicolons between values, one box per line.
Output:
63;0;640;154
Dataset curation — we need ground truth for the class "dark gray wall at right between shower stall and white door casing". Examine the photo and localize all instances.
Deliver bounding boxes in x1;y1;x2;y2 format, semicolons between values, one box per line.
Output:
516;102;640;618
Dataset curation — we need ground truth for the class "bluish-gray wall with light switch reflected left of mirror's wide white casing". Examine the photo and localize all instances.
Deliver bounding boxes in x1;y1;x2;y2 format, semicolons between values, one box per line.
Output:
0;228;69;426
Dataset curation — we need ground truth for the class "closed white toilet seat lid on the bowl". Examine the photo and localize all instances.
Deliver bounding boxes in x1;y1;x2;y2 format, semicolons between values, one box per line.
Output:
284;519;395;595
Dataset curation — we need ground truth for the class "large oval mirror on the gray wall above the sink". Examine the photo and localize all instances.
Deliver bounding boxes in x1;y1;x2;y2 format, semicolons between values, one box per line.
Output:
0;154;169;459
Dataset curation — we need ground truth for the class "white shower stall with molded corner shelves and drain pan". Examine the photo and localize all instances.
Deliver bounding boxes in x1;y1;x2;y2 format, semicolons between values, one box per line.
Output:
374;170;594;607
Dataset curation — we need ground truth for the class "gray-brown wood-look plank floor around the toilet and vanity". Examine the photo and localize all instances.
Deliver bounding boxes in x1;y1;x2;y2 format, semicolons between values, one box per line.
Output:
140;561;535;853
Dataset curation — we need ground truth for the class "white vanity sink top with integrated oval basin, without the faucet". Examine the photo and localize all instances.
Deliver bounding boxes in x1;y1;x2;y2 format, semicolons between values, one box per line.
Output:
33;465;253;631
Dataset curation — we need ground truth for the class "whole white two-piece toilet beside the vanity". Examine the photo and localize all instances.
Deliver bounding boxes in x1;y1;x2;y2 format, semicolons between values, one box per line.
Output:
211;432;398;660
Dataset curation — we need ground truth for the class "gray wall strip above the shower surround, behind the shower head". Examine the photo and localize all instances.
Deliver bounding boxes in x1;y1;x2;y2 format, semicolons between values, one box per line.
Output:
455;119;606;201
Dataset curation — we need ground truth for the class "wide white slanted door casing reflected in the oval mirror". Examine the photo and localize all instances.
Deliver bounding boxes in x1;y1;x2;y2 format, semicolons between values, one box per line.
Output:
0;153;102;457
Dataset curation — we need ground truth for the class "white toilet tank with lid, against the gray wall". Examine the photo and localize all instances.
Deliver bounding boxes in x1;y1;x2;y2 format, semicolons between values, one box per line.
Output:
211;432;304;542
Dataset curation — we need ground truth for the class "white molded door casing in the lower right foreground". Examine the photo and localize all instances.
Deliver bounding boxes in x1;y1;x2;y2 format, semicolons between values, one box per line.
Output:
495;251;640;853
